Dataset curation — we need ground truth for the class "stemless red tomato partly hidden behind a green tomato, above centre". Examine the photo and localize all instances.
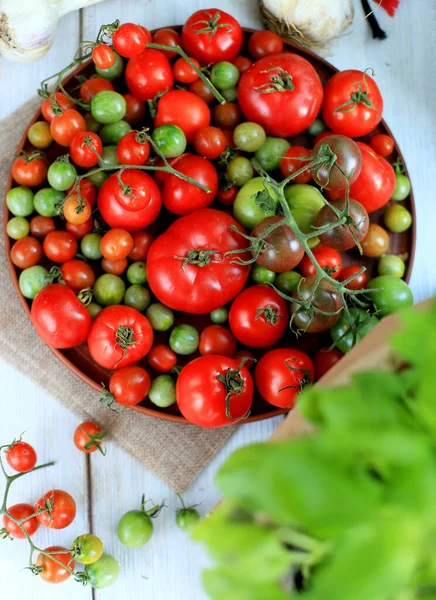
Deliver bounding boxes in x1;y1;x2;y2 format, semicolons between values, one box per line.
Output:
154;90;210;144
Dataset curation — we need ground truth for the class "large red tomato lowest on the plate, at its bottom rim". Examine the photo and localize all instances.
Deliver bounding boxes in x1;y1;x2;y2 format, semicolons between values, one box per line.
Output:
176;354;253;429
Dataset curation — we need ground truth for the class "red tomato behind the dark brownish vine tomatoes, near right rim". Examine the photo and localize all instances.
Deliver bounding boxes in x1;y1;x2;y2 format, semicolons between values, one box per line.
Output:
327;142;395;213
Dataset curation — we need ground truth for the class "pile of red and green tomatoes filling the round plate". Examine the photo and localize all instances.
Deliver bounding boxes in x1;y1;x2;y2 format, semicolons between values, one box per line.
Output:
7;9;412;427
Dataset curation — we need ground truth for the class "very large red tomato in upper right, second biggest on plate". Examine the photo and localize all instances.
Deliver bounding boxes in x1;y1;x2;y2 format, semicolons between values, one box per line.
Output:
238;53;323;137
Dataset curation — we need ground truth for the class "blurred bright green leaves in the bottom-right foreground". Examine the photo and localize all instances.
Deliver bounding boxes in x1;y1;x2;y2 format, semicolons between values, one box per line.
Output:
195;303;436;600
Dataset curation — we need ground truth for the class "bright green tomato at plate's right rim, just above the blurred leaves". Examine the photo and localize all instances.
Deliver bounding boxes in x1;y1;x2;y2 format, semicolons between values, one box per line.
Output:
368;275;413;317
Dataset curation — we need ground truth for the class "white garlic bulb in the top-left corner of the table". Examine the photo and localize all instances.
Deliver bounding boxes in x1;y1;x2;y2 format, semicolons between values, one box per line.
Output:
0;0;102;61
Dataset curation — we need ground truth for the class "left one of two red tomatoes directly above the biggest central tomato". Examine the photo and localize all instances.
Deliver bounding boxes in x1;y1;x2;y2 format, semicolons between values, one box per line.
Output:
98;169;162;231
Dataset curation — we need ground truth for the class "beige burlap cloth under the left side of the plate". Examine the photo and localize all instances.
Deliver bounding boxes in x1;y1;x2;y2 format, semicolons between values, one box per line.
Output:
0;98;235;492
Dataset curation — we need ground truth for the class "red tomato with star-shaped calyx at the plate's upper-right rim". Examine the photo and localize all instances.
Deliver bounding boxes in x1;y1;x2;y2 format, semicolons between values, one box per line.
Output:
322;70;383;138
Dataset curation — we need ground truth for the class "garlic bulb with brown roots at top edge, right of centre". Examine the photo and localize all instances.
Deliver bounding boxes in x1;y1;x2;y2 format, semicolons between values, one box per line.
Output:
260;0;354;48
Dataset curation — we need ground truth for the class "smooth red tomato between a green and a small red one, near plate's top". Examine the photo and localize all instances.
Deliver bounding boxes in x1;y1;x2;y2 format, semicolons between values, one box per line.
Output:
125;48;174;101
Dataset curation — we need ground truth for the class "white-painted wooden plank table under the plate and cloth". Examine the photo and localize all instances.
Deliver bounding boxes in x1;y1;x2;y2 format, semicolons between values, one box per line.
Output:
0;0;436;600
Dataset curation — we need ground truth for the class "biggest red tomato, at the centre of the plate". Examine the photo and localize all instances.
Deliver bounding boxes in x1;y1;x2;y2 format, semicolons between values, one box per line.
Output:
147;208;250;314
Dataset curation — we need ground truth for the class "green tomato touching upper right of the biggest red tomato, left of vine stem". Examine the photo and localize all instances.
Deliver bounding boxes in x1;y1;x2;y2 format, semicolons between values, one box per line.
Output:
233;177;278;230
